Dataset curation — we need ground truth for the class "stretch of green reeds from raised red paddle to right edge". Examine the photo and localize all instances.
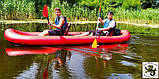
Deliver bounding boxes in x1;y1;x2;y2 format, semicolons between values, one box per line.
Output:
47;0;159;24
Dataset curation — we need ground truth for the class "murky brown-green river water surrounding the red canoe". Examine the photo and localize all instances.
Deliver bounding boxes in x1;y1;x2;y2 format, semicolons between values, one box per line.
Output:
0;23;159;79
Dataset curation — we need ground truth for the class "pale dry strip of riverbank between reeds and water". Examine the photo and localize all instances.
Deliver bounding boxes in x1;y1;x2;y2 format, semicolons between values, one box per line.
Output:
0;19;159;28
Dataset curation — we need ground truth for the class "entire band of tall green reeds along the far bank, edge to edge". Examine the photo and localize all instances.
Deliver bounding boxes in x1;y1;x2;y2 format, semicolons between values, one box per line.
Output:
0;0;159;24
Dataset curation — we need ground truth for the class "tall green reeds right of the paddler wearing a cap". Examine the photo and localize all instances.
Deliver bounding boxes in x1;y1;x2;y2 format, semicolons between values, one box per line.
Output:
114;8;159;24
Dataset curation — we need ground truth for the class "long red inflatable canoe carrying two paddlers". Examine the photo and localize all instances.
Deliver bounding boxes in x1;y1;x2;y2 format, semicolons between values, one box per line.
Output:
4;28;130;45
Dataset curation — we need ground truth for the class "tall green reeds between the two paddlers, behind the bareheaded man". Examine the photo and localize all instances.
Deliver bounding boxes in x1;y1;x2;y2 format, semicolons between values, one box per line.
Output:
49;0;98;21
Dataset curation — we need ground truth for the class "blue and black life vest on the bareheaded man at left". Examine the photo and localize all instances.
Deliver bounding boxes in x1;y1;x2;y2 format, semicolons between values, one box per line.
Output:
55;16;67;33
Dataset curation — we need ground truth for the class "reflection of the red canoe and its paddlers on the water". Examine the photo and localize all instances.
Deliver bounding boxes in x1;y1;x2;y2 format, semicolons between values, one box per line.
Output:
6;44;129;79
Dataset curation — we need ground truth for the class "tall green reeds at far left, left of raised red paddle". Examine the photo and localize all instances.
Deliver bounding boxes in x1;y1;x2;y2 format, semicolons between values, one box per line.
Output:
0;0;35;19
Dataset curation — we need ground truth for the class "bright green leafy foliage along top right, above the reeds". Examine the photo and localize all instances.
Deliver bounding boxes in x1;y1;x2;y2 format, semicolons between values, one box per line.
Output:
79;0;159;10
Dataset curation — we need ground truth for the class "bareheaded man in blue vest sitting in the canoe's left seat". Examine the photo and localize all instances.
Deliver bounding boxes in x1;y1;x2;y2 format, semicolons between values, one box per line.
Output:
38;8;67;36
